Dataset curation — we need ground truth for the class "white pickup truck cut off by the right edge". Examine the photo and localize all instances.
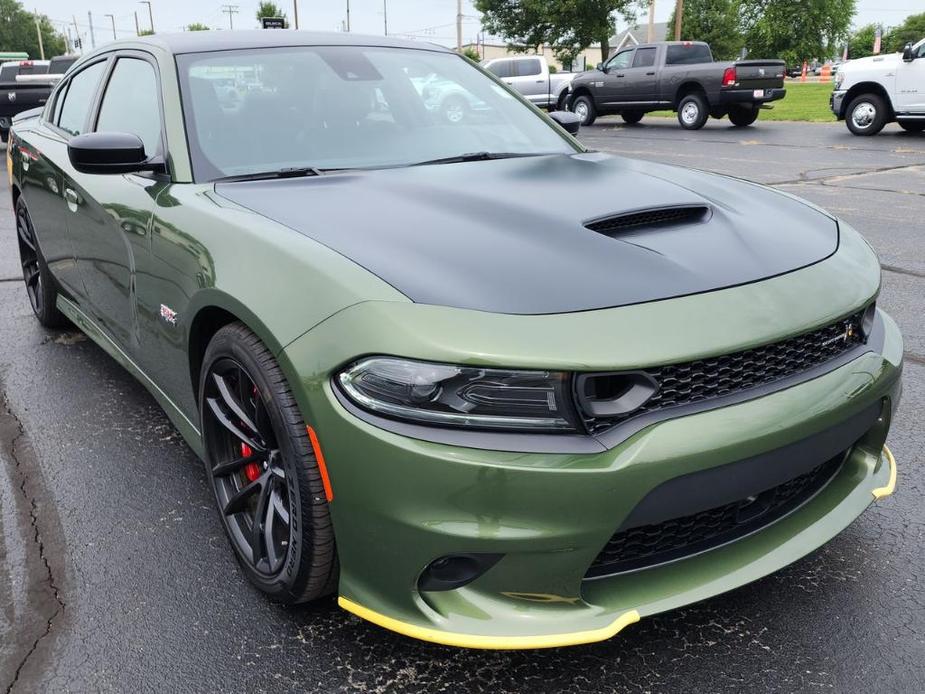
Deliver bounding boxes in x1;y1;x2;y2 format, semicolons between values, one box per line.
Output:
830;39;925;135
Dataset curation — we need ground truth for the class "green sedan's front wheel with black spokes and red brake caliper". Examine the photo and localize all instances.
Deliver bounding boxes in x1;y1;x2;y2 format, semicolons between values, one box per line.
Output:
199;323;338;605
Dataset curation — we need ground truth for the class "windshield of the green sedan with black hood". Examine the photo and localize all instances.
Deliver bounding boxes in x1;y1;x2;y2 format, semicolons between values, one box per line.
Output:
177;46;577;181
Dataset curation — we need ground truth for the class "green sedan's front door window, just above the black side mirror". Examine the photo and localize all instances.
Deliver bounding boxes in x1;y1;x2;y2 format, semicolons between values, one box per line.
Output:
96;58;161;157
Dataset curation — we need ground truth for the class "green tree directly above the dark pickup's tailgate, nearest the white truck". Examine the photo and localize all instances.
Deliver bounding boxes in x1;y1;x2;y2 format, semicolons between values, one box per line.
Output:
742;0;855;65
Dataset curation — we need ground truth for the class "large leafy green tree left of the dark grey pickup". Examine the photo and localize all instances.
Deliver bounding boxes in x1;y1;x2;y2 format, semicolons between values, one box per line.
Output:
474;0;636;64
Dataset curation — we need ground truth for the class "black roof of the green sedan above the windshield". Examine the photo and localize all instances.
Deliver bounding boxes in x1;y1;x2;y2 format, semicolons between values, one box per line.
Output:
121;29;449;53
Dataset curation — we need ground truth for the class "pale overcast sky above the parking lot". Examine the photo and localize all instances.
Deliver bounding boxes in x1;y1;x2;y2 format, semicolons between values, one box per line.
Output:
25;0;923;52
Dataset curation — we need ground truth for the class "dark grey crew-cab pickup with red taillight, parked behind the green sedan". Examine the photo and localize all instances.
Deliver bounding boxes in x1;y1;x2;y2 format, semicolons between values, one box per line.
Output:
568;41;787;130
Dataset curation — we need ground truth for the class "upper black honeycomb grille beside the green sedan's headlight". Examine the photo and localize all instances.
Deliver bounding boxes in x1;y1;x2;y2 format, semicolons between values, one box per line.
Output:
578;311;866;433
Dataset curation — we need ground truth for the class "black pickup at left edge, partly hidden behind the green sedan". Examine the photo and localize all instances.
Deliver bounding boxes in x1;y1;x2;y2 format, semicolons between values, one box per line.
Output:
0;55;77;142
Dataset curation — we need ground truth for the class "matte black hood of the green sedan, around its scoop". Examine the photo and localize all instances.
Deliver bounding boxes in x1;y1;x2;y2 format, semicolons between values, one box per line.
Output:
215;153;838;314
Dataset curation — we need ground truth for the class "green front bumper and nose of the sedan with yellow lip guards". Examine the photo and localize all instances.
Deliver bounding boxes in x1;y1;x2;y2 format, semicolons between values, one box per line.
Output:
280;226;902;648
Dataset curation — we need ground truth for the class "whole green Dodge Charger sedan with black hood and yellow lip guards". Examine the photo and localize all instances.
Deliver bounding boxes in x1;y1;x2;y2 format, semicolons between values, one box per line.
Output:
7;31;903;648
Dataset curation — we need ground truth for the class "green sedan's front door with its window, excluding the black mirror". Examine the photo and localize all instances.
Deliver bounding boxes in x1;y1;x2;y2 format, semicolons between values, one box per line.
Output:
64;52;169;356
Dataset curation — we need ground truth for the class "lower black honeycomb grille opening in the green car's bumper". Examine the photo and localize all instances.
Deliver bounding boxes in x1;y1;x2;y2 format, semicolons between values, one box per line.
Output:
585;453;845;578
